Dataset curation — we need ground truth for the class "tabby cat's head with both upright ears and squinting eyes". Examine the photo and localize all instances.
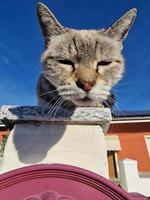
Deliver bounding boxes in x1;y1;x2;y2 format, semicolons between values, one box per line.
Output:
37;3;136;106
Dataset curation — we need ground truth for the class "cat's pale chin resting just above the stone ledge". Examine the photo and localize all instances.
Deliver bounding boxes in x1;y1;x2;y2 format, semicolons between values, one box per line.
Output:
71;98;103;107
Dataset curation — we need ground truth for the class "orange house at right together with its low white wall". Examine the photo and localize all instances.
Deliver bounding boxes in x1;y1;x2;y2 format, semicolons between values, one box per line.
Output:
106;111;150;196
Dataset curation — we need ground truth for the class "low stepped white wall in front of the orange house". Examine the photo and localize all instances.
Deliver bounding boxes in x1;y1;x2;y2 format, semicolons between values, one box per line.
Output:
119;159;150;196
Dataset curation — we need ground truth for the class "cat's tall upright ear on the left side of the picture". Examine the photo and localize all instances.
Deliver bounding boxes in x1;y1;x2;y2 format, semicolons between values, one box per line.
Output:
37;2;64;46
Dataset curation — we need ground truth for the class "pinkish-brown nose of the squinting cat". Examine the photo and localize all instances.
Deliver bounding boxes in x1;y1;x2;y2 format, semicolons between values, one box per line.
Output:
76;80;96;92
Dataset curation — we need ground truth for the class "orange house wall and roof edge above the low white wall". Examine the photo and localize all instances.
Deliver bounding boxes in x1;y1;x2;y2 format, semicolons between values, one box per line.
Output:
107;111;150;180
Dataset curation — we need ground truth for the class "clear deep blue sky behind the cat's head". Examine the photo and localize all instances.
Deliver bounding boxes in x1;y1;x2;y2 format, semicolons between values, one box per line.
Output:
0;0;150;112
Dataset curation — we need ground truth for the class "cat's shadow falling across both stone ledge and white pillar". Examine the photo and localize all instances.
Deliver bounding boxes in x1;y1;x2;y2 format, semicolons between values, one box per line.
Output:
3;106;74;164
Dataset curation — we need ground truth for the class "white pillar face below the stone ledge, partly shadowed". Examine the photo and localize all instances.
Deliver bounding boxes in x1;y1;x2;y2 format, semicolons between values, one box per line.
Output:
0;123;108;178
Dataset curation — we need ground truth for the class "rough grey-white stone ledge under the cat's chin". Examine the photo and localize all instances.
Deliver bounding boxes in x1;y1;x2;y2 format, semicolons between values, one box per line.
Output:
0;106;111;130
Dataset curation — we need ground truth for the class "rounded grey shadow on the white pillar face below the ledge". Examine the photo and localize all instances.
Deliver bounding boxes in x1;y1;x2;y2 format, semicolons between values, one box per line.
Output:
13;123;66;164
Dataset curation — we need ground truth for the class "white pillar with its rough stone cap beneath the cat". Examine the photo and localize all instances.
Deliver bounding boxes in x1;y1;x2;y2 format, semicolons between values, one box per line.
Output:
0;106;111;178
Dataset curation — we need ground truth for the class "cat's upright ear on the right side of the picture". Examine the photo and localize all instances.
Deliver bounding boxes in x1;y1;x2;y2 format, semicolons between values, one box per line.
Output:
105;8;137;42
